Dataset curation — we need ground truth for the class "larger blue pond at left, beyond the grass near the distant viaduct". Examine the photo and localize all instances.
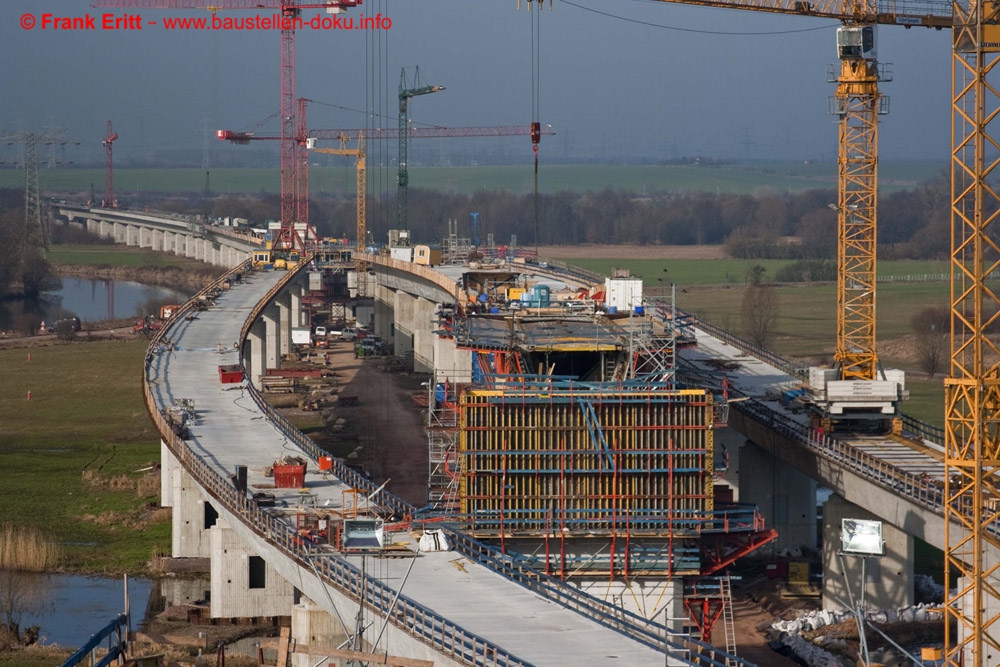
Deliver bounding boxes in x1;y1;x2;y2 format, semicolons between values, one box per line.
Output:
0;278;194;331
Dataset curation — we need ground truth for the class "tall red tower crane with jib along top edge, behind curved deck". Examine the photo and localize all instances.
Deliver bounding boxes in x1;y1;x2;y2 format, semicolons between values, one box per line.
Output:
93;0;361;251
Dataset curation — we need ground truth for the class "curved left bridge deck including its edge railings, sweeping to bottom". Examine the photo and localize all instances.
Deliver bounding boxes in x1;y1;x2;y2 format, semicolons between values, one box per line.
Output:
146;264;746;666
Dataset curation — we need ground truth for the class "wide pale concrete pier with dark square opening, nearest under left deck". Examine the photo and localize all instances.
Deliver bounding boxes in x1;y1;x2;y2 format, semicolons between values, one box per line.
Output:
209;519;295;618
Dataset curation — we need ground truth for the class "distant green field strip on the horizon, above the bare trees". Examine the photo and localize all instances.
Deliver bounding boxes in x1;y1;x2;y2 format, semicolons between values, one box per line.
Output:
0;162;942;201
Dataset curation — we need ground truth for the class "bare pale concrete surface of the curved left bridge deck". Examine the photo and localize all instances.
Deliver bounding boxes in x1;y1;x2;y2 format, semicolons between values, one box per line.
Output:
146;264;723;666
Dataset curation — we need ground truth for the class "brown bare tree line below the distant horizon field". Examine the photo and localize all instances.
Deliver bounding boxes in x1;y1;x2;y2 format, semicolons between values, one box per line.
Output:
157;178;950;260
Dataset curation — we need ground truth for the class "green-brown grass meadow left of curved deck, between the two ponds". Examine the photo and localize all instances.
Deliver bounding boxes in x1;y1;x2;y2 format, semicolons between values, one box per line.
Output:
0;341;170;573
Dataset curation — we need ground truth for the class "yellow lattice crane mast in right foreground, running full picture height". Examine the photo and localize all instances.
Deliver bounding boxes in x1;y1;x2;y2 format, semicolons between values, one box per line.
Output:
944;0;1000;667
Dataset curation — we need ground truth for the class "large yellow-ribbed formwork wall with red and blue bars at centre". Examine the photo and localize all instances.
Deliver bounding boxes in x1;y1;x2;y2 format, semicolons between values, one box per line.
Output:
458;383;714;538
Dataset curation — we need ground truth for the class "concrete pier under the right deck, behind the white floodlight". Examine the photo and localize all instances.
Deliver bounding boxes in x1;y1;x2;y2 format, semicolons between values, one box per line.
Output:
823;494;913;609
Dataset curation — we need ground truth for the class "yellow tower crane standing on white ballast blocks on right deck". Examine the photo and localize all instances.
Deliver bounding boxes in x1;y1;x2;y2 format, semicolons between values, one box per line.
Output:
556;0;952;428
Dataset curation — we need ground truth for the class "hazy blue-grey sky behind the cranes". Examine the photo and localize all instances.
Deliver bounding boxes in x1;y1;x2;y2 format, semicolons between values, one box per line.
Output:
0;0;951;166
